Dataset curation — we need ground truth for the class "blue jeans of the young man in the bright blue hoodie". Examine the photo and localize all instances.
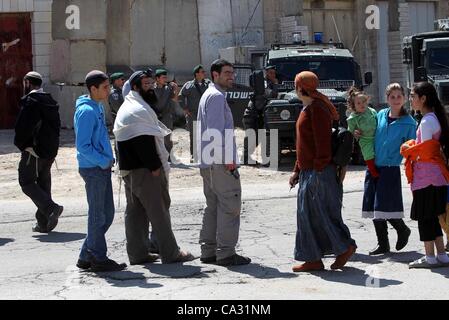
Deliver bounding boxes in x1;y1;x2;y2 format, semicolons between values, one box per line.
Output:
79;168;115;261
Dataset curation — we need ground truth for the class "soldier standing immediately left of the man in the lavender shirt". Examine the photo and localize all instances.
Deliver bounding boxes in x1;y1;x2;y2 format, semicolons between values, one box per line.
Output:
178;65;211;162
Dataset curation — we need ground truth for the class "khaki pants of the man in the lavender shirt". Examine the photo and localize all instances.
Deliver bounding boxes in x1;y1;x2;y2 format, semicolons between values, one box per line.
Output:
200;165;242;260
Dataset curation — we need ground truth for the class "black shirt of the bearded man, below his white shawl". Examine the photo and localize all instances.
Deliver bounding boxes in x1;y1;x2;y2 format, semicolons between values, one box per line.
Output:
117;136;162;171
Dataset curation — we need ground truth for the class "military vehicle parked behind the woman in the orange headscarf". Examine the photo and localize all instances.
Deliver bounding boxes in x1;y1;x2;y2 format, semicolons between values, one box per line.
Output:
264;43;372;164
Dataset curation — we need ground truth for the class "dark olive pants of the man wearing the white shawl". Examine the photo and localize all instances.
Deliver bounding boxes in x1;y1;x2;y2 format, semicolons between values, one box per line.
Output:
124;169;179;263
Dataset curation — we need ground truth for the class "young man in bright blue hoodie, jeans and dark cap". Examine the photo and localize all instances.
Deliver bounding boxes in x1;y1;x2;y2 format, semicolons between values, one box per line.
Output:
74;70;126;272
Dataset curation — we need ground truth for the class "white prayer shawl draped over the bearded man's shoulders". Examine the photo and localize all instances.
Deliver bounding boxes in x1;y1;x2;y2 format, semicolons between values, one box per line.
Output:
114;91;172;181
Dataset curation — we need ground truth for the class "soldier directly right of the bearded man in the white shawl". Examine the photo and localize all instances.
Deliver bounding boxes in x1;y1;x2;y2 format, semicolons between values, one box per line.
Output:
154;69;179;153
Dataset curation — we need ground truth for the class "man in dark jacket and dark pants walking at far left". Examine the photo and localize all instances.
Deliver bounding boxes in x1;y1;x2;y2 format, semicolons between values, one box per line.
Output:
14;72;63;233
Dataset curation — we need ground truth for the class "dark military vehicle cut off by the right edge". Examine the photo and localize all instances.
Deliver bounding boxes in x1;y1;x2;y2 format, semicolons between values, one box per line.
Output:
403;27;449;111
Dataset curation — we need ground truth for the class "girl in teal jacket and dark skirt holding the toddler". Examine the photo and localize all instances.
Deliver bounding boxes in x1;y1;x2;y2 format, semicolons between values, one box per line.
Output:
356;83;416;255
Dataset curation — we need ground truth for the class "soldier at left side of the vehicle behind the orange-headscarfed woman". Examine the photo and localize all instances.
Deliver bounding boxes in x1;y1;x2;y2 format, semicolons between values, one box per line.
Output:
242;66;279;164
